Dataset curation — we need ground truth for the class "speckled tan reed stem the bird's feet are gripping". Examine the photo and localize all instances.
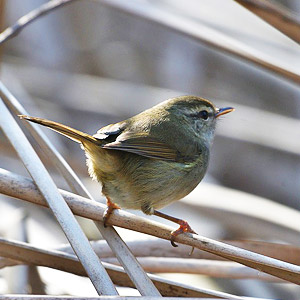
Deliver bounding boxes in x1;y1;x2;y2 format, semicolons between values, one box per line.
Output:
0;170;300;284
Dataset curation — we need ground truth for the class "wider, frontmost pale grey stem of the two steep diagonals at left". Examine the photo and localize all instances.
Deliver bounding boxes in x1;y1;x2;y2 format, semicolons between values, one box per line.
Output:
0;98;118;295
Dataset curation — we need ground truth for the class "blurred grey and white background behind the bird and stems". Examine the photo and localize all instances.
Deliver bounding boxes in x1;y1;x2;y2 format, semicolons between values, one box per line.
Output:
0;0;300;299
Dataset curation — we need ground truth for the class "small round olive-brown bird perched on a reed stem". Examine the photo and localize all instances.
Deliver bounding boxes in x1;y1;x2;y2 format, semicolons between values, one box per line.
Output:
19;96;234;247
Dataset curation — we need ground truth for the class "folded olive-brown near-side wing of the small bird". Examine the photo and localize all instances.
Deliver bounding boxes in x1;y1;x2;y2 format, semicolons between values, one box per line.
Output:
102;131;179;162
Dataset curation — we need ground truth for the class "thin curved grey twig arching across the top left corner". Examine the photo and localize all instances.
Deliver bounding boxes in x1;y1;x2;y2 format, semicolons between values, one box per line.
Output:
0;0;76;45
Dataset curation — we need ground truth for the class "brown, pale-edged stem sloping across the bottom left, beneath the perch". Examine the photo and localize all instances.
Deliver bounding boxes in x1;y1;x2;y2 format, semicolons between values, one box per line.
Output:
0;238;241;299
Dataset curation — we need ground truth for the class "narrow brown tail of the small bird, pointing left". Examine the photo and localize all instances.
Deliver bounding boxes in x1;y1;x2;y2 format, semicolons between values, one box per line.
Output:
19;115;99;144
